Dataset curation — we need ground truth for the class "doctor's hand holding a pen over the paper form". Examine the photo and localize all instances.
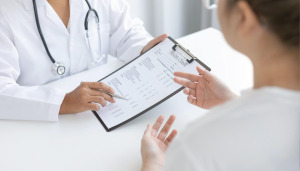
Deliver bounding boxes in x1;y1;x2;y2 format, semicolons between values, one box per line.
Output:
59;82;115;114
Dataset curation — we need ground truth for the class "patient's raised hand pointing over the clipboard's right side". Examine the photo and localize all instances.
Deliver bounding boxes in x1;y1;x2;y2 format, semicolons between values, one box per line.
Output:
174;66;237;109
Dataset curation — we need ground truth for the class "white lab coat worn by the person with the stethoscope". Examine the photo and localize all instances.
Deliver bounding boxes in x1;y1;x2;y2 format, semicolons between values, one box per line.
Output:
0;0;151;121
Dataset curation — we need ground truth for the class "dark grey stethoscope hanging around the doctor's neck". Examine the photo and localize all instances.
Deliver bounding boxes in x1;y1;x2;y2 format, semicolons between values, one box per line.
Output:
32;0;105;76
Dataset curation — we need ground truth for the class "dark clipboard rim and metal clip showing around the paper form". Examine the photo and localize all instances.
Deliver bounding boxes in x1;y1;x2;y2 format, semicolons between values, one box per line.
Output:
92;37;211;132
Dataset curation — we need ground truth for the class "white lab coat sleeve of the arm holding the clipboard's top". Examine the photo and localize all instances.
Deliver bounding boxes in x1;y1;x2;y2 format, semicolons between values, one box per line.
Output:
109;0;152;62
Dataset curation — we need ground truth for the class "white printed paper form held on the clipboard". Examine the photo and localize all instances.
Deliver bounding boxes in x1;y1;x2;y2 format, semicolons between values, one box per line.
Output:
96;39;210;129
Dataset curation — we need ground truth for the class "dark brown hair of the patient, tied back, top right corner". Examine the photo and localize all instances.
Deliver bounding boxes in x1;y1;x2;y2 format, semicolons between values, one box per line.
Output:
229;0;299;48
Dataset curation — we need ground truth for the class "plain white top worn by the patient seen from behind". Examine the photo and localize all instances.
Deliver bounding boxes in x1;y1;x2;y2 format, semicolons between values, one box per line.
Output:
165;87;300;171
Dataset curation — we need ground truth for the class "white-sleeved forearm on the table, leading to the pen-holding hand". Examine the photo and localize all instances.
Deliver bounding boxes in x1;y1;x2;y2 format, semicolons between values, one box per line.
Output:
0;83;65;121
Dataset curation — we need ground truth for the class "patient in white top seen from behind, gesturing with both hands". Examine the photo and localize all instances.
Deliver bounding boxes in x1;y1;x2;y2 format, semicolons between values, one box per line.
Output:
141;0;300;171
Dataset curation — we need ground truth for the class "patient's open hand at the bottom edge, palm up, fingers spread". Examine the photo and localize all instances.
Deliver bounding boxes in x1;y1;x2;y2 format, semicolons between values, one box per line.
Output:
141;115;177;171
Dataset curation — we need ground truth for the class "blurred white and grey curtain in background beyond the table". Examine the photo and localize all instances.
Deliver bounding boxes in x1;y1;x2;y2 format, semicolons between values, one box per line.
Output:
127;0;219;39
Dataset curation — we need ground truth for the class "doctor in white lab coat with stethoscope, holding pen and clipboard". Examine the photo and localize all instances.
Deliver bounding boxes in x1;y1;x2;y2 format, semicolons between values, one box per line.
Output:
0;0;166;121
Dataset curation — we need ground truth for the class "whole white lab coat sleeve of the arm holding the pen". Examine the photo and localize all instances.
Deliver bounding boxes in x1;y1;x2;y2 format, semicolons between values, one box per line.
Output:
0;9;66;121
